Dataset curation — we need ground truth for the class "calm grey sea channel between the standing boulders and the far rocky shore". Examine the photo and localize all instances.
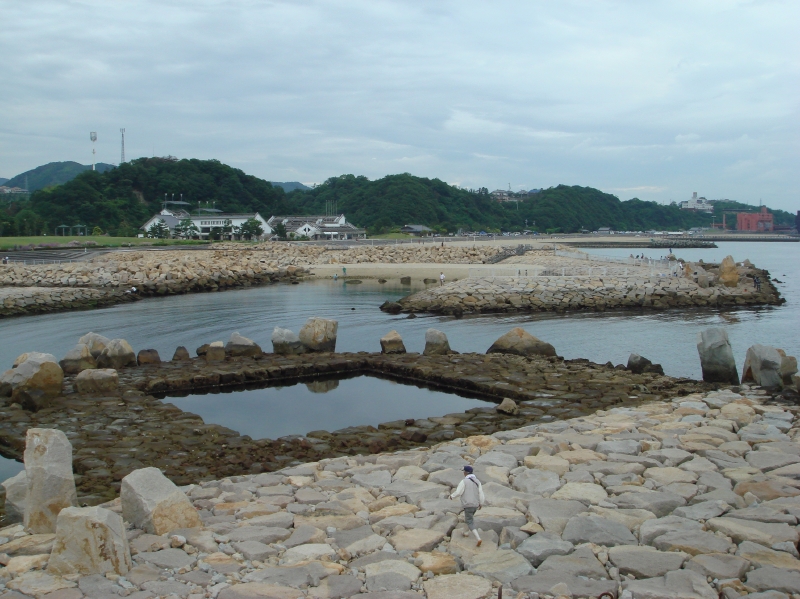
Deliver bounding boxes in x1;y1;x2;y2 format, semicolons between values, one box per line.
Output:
0;242;800;477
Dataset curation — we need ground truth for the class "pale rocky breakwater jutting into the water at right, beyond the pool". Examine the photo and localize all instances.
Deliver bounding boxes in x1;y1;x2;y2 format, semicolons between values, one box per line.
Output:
392;273;784;315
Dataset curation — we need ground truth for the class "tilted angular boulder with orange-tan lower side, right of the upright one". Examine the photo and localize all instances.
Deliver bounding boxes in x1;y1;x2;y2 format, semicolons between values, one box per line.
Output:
120;467;202;535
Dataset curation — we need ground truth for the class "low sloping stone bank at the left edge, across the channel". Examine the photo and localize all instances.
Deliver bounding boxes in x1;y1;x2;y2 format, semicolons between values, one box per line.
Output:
0;287;137;318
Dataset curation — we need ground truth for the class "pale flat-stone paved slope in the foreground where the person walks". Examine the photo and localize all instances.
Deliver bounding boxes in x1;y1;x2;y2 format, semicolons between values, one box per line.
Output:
0;385;800;599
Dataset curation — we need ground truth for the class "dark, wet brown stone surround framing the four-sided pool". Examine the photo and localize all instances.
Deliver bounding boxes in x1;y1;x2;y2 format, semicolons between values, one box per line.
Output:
0;353;711;510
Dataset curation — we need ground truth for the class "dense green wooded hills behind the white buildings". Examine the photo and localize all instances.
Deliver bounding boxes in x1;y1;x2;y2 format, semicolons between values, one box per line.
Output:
0;157;794;236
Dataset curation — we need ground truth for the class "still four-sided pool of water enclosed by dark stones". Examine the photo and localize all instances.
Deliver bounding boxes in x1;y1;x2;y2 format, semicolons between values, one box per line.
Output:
164;376;495;439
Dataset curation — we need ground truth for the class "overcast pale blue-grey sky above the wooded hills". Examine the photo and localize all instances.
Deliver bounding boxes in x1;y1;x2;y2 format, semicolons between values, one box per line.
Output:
0;0;800;210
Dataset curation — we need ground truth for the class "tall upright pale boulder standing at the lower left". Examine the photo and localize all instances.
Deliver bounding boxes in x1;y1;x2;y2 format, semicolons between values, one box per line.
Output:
24;428;78;534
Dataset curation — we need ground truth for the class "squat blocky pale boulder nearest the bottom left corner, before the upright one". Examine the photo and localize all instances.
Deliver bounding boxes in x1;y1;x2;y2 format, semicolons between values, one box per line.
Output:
47;507;131;576
